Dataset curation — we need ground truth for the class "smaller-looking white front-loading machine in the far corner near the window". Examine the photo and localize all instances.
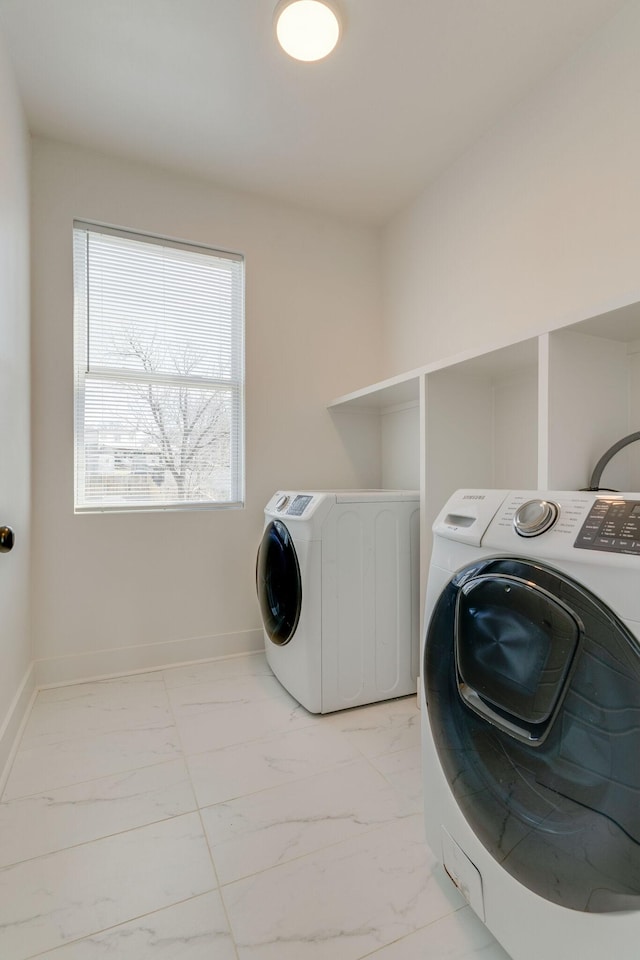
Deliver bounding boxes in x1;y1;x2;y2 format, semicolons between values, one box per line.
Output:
256;490;420;713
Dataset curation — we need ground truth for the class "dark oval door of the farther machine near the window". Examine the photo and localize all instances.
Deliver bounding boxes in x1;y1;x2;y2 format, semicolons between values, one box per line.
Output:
256;520;302;646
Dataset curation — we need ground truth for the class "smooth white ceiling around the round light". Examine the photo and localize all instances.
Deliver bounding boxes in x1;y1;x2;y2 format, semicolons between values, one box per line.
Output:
0;0;625;223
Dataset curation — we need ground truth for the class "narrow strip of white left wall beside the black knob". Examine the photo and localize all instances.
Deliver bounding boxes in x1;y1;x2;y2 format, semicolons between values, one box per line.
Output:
0;35;33;772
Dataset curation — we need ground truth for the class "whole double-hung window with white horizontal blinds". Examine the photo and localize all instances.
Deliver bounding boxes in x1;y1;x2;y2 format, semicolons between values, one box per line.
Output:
73;222;244;512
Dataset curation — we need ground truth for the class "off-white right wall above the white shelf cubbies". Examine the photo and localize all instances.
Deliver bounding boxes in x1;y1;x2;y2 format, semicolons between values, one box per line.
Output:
383;2;640;376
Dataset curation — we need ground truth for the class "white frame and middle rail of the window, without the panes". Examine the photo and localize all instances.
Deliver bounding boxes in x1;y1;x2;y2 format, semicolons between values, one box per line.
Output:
72;219;246;514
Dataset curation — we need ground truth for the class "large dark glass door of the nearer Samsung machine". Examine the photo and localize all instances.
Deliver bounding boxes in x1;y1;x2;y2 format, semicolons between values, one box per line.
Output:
423;558;640;913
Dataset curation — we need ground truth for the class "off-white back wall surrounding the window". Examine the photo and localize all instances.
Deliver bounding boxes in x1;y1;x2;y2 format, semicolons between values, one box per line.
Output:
32;140;380;682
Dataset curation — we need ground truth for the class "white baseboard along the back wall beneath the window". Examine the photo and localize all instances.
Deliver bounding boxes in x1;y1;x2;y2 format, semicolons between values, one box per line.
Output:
34;630;264;688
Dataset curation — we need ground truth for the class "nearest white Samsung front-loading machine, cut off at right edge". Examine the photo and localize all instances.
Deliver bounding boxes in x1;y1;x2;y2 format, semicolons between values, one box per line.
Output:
420;490;640;960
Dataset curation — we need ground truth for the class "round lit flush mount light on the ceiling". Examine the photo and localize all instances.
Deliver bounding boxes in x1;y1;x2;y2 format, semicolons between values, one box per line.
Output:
274;0;342;62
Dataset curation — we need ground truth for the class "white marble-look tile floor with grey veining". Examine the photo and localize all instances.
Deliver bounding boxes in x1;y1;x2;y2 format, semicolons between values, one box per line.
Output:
0;654;508;960
